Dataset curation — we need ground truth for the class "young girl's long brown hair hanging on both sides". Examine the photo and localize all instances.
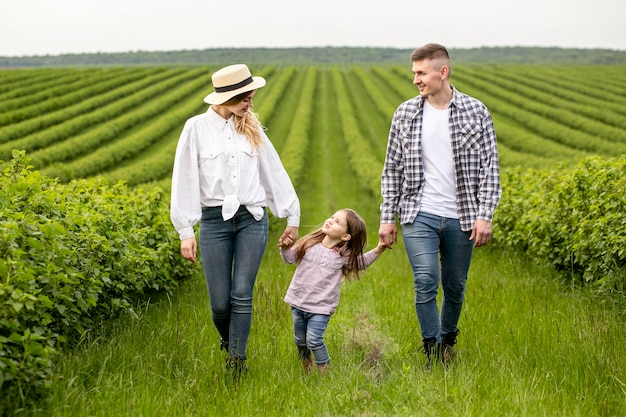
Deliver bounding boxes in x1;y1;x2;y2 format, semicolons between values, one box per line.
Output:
295;208;367;280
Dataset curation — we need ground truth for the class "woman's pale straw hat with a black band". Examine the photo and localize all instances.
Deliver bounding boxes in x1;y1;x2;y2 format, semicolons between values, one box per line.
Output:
204;64;265;104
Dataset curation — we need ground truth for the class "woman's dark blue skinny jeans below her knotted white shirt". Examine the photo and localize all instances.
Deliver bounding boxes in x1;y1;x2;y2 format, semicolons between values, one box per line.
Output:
200;206;268;359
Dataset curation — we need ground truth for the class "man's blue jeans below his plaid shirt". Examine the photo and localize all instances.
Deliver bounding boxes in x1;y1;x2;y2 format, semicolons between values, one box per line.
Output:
402;212;474;342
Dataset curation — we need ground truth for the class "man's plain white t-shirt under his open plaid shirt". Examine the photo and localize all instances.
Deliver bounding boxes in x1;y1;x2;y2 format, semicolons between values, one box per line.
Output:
420;100;459;219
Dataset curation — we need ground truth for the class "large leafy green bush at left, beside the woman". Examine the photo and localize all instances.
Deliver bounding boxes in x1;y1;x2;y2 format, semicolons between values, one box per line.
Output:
0;152;195;409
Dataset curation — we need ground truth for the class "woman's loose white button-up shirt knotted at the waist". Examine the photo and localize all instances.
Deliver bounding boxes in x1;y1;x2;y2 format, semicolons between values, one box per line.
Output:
170;108;300;240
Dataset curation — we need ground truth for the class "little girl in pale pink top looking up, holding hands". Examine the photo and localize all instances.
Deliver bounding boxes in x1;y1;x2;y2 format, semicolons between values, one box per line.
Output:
279;209;385;373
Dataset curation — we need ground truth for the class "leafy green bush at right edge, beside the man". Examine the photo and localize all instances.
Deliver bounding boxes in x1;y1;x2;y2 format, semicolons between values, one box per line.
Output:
494;157;626;291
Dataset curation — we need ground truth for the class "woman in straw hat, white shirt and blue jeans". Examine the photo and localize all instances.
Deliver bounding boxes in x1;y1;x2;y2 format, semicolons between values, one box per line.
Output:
170;64;300;377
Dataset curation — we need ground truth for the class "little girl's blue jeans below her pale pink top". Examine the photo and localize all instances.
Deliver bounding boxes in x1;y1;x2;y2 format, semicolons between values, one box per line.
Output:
291;307;330;365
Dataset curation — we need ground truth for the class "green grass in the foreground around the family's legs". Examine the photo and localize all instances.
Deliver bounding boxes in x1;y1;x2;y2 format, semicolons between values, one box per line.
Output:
23;236;626;417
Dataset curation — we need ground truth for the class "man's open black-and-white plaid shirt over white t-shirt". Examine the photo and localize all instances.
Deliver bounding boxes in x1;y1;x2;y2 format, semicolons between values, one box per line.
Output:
380;86;502;231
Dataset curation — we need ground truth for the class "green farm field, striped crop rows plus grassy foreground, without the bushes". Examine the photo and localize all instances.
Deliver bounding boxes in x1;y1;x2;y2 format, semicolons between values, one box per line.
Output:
0;65;626;417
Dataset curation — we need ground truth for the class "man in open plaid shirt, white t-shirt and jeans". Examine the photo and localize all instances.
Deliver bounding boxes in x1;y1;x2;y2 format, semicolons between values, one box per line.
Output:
378;44;502;369
